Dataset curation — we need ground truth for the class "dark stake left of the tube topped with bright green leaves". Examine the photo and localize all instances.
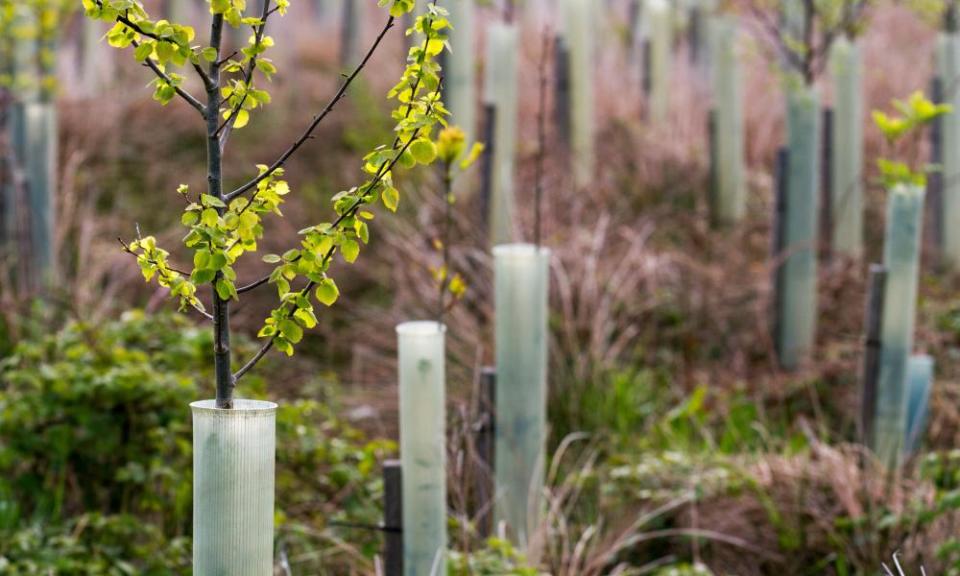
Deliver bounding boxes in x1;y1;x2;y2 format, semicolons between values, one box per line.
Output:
860;264;887;446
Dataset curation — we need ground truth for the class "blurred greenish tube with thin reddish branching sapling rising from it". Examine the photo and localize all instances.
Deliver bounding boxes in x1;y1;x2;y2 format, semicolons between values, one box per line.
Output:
779;87;820;370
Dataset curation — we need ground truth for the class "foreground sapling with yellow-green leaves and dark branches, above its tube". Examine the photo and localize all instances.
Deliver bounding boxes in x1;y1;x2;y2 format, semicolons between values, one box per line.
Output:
83;0;449;408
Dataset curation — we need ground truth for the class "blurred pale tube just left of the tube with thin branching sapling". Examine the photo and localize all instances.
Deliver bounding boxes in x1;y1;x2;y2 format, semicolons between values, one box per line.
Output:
708;16;746;225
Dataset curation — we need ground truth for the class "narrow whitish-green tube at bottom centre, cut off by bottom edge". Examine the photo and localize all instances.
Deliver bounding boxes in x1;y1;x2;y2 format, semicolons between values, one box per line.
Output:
397;322;447;576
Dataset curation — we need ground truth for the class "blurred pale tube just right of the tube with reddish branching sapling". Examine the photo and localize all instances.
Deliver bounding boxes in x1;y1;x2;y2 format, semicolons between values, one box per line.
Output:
830;37;863;257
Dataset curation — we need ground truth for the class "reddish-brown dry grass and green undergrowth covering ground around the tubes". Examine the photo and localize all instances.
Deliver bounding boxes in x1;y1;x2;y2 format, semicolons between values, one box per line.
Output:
7;2;960;576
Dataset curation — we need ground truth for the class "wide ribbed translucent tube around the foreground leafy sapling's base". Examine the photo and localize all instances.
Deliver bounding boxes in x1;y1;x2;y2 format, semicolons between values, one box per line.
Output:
190;400;277;576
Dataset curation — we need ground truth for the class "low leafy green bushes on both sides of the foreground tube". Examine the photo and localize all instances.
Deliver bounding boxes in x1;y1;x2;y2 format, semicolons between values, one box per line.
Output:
0;311;395;575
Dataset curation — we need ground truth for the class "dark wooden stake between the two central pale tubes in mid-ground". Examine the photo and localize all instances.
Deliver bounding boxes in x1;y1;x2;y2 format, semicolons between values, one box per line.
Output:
474;366;497;538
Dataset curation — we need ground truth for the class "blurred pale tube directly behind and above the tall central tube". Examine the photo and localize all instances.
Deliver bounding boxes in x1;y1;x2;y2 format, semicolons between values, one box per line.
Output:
483;22;519;245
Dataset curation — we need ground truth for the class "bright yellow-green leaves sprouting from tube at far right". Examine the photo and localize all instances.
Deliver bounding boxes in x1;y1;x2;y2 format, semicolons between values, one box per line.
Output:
873;91;952;190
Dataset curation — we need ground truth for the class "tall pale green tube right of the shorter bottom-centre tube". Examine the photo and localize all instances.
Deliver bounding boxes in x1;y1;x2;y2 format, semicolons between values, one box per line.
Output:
493;244;550;548
